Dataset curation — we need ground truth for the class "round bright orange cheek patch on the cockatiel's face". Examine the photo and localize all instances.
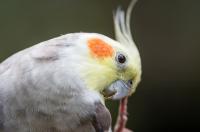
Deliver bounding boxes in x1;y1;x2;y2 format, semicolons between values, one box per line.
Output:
88;38;113;58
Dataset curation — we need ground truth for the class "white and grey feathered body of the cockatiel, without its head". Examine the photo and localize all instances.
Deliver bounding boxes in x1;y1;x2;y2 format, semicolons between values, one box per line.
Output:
0;33;113;132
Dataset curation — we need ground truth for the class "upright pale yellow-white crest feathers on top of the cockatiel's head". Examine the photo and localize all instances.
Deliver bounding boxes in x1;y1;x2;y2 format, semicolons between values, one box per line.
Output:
113;0;137;47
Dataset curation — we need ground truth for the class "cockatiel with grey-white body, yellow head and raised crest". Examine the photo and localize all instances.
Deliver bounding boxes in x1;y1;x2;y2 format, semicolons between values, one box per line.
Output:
0;1;141;132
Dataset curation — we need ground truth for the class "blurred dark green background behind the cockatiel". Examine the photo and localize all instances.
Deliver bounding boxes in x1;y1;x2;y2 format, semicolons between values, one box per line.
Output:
0;0;200;132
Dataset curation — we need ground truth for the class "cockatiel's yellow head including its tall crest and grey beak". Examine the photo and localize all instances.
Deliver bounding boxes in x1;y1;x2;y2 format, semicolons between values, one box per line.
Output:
78;0;141;99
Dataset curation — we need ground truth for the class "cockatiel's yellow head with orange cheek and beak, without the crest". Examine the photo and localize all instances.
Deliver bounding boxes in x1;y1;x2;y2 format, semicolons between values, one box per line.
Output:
77;33;141;99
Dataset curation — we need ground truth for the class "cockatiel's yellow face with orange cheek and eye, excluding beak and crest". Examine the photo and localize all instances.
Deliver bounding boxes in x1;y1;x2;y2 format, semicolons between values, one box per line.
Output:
79;38;141;98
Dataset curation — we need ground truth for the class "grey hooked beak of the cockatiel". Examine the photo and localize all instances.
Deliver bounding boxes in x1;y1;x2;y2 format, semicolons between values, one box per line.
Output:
102;80;131;100
